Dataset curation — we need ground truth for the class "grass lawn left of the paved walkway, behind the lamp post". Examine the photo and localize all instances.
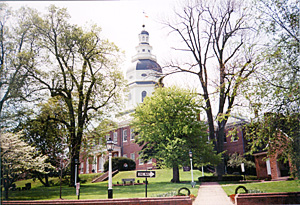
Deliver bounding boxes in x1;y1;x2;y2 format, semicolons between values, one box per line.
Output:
4;169;207;200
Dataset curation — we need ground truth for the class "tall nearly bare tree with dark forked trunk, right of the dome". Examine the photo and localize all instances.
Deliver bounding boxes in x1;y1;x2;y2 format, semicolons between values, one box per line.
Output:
165;0;257;176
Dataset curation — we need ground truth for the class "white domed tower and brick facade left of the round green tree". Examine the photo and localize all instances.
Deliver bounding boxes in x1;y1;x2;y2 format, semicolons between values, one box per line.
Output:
80;25;162;173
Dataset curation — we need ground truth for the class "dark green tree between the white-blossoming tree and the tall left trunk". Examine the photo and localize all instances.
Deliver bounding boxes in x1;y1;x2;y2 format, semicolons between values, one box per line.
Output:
19;97;67;187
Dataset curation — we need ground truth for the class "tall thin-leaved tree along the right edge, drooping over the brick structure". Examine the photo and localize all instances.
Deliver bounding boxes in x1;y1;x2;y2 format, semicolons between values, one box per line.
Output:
247;0;300;177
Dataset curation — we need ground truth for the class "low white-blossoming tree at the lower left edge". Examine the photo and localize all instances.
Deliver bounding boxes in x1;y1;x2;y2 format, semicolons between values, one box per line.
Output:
0;133;53;199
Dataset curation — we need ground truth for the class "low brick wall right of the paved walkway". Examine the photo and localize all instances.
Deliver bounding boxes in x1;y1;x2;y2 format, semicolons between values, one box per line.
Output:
235;192;300;205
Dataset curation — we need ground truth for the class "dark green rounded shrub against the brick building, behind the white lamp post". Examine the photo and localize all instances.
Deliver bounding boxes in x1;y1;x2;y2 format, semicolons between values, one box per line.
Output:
104;157;136;172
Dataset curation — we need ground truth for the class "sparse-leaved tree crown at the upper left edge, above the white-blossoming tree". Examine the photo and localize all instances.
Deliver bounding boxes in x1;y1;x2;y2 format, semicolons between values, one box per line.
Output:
0;3;36;126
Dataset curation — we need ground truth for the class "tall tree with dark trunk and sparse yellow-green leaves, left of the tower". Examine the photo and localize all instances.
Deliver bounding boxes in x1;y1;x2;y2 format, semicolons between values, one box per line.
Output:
24;5;123;185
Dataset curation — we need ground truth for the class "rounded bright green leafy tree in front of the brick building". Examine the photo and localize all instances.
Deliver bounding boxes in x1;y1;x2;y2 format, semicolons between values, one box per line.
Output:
131;87;220;182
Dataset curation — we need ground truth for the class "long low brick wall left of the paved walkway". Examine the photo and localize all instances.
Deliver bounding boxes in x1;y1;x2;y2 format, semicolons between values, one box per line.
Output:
2;196;192;205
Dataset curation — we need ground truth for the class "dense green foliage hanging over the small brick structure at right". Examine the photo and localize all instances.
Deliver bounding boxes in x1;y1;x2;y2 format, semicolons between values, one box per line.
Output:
246;113;300;177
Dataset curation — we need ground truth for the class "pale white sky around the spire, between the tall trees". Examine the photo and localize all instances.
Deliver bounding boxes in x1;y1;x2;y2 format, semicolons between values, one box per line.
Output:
6;0;178;76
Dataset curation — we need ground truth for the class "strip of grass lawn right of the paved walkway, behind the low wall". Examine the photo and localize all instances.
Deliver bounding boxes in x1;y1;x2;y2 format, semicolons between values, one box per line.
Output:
222;180;300;195
